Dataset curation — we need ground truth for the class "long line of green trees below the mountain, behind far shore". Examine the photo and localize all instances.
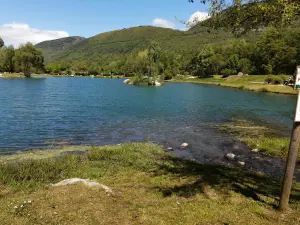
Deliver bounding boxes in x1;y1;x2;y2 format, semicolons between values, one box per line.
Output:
46;28;300;79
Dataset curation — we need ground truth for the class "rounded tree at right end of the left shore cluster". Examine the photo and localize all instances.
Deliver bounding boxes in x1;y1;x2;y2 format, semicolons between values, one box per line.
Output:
16;43;44;77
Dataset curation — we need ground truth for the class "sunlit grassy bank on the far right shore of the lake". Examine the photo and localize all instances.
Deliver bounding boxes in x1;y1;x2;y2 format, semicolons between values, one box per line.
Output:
171;75;297;94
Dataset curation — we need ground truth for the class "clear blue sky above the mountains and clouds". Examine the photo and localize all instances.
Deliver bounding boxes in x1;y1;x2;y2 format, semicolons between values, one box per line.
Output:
0;0;207;46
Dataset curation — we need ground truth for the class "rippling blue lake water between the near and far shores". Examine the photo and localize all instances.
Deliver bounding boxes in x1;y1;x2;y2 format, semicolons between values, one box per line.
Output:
0;77;296;178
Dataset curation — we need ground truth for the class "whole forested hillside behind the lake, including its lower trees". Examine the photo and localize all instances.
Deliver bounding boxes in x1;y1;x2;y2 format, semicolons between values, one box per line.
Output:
37;24;300;79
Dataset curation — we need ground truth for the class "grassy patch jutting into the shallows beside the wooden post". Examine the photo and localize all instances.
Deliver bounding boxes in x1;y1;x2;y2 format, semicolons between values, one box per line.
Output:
219;120;300;161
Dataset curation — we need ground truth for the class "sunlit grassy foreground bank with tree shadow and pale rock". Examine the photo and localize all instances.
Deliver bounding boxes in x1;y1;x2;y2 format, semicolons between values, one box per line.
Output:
0;143;300;224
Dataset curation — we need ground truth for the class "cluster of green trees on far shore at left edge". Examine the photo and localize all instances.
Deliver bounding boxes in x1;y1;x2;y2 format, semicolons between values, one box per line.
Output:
0;38;45;77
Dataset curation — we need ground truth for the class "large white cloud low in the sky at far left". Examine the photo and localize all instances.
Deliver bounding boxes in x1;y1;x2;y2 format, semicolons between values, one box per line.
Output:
0;22;69;47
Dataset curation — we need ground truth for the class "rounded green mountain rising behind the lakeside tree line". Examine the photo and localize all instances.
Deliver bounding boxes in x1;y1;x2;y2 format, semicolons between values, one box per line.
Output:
36;26;255;63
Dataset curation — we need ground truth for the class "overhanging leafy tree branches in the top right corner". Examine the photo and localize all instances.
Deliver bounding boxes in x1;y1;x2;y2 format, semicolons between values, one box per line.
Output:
188;0;300;33
